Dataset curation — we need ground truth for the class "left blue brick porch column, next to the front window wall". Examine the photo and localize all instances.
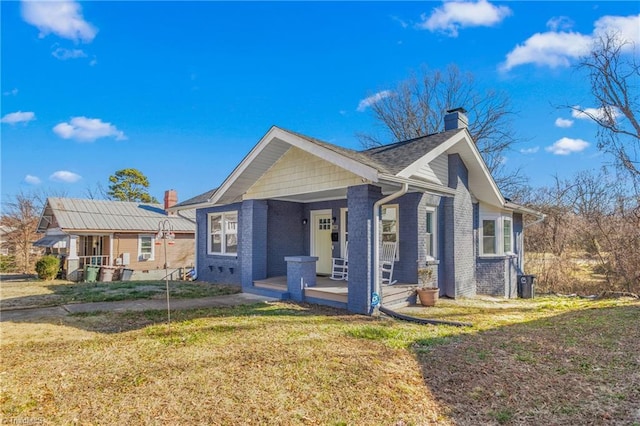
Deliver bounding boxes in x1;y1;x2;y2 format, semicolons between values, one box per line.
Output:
238;200;267;291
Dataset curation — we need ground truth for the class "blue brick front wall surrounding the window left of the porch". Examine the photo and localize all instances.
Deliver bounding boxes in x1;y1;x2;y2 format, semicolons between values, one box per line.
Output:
196;203;242;285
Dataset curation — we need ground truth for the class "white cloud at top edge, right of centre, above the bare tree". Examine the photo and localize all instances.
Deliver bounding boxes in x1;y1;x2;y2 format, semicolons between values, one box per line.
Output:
418;0;511;37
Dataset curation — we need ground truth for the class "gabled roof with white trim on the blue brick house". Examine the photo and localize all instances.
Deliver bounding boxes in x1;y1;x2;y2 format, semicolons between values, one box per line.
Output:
170;126;506;210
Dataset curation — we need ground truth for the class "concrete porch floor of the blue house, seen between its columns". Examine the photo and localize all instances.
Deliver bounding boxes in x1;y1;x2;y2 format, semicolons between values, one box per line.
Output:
253;275;418;309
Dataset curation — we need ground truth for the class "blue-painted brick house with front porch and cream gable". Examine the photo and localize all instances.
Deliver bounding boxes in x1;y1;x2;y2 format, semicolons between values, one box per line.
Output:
173;109;543;314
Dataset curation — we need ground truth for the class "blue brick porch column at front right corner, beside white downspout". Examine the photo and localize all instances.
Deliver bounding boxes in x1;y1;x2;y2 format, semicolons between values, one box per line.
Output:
347;185;382;315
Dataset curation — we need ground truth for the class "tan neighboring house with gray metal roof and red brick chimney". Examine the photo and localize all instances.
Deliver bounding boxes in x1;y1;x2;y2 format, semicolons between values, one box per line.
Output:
34;190;196;281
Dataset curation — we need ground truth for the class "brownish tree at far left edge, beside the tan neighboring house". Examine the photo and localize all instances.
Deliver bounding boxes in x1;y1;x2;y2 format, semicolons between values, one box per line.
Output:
0;192;42;273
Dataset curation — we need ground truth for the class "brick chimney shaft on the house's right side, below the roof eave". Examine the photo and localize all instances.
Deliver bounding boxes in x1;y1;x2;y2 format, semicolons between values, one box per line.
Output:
441;154;476;297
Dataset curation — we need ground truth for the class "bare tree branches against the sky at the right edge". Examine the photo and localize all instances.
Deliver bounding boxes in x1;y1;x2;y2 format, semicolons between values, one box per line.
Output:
571;33;640;186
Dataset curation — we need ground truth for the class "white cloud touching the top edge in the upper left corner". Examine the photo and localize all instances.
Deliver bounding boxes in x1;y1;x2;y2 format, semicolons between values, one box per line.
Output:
22;0;98;43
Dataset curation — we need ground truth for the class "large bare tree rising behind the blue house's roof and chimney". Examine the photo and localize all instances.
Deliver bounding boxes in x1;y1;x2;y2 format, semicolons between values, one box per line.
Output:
358;65;526;194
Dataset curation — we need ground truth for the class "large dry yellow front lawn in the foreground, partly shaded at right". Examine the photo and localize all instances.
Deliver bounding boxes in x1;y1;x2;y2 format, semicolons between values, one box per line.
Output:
0;297;640;425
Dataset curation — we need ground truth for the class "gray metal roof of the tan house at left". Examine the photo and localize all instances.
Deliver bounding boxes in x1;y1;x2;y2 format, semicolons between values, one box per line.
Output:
38;197;195;233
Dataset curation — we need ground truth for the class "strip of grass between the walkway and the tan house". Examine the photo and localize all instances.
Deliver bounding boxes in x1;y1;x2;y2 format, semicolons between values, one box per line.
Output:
0;280;240;309
